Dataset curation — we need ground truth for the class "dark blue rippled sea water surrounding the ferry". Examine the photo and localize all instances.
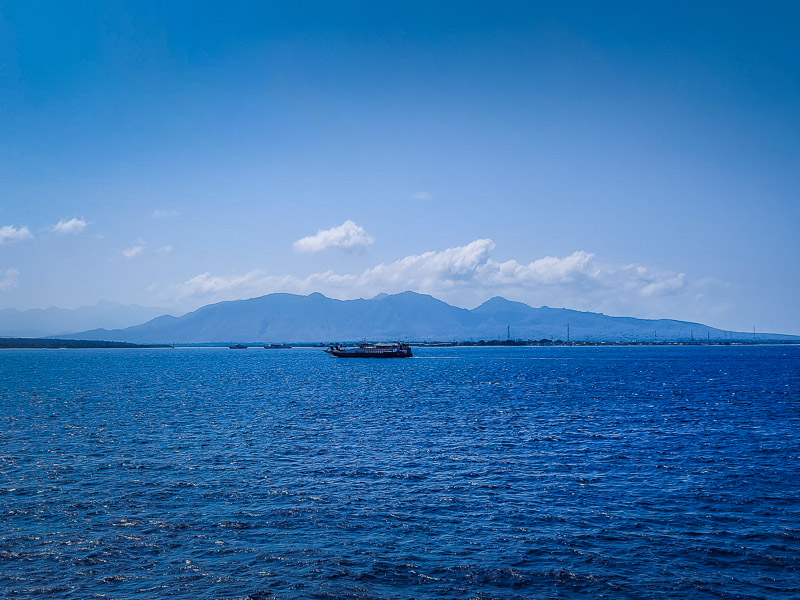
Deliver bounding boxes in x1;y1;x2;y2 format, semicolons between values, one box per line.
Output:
0;346;800;600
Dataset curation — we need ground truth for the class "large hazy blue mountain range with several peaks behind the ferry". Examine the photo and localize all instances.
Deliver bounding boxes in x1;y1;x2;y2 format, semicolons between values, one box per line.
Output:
57;292;800;343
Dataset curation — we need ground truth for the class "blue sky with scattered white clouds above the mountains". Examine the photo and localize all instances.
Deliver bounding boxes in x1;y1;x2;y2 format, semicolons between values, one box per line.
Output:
0;0;800;334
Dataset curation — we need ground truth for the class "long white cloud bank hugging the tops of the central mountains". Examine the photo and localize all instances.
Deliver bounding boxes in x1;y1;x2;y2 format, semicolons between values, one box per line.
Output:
171;239;726;318
